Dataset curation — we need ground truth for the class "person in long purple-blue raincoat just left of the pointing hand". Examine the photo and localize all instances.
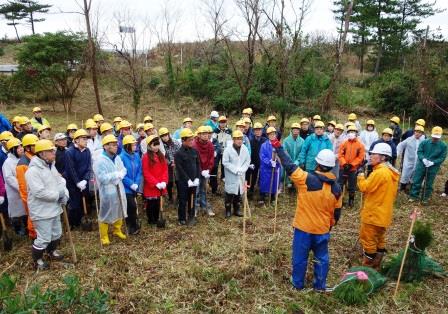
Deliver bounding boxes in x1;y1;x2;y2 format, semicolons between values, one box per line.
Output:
259;127;280;204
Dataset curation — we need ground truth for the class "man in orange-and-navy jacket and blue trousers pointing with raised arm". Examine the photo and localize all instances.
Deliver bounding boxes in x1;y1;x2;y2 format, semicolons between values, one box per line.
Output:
271;139;342;291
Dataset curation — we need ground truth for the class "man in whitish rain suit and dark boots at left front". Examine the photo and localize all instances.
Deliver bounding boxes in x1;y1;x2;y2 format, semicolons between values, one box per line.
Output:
25;140;68;270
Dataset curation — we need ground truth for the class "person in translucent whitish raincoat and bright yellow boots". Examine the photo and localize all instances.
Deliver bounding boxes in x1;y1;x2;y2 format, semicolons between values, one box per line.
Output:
93;134;127;245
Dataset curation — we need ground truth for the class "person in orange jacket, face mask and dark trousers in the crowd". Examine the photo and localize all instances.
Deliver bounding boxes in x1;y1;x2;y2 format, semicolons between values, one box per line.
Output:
338;125;365;207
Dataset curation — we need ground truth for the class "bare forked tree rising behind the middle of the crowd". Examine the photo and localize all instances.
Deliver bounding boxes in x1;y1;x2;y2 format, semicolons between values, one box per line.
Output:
223;0;263;106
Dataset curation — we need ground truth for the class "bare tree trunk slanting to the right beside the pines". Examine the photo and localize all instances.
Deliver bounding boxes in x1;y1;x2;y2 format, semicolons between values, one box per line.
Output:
322;0;355;112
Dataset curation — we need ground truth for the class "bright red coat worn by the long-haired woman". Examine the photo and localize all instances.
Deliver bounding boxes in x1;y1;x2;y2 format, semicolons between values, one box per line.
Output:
142;153;168;197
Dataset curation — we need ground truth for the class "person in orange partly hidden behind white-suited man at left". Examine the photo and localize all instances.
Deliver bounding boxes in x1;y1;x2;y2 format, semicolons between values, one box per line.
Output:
16;134;39;239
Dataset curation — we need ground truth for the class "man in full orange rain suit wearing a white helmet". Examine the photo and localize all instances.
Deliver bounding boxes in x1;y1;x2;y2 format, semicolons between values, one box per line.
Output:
358;143;400;269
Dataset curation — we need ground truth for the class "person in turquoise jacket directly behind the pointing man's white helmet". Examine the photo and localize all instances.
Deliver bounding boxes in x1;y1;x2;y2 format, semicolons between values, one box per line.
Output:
299;121;333;172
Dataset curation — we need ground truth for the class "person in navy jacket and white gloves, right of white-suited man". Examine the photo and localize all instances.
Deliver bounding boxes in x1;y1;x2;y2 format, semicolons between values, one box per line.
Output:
64;129;92;228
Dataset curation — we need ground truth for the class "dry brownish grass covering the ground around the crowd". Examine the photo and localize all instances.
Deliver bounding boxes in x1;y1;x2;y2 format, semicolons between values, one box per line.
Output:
0;95;448;313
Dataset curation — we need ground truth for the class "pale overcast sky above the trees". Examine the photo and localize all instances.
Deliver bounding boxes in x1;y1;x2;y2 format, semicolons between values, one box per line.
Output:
0;0;448;46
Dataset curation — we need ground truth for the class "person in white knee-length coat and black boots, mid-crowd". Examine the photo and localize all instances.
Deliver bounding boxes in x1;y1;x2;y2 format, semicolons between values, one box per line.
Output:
222;130;250;218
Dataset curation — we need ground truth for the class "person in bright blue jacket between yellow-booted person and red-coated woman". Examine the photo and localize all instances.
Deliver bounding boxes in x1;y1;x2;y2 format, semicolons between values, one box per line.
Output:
120;135;142;235
